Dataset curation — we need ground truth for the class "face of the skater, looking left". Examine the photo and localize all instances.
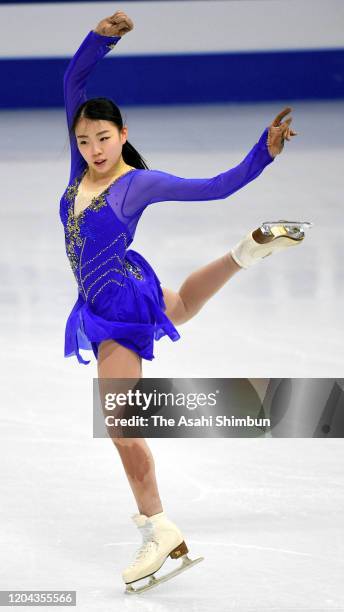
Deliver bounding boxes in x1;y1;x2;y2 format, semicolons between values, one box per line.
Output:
75;117;128;174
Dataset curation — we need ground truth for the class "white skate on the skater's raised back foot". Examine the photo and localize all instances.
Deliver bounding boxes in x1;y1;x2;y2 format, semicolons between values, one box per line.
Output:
230;220;313;268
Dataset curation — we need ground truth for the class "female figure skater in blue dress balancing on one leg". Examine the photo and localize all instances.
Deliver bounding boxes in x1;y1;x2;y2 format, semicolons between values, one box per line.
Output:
60;11;304;592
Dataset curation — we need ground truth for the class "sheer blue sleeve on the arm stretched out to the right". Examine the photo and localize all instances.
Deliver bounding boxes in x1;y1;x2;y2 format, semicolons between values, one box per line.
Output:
120;128;275;223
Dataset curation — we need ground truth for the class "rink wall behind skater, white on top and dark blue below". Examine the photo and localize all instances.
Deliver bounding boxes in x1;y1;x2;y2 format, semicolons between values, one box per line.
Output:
0;0;344;109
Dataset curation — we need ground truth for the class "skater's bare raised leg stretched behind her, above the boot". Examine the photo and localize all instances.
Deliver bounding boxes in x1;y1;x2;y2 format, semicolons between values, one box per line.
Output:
163;253;242;325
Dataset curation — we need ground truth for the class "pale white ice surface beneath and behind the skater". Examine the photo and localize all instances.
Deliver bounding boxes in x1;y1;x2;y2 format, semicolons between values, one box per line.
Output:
0;100;344;612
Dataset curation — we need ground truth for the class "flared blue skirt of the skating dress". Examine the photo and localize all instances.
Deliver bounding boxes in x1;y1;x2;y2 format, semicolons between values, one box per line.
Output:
64;249;180;365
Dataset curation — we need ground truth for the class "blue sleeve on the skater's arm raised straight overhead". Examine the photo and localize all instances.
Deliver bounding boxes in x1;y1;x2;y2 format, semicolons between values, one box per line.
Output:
63;30;121;182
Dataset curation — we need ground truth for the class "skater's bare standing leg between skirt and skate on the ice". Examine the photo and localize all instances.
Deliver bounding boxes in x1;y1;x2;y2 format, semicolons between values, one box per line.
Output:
98;340;163;516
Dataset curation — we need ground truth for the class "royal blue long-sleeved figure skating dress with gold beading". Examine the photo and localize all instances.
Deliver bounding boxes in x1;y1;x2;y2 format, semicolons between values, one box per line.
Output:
60;31;274;364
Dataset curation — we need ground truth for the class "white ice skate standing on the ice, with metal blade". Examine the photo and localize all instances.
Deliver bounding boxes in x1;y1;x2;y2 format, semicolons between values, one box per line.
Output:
122;512;204;594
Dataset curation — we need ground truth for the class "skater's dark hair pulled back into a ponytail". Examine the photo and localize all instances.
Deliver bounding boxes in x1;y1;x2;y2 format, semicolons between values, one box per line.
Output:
69;98;149;170
